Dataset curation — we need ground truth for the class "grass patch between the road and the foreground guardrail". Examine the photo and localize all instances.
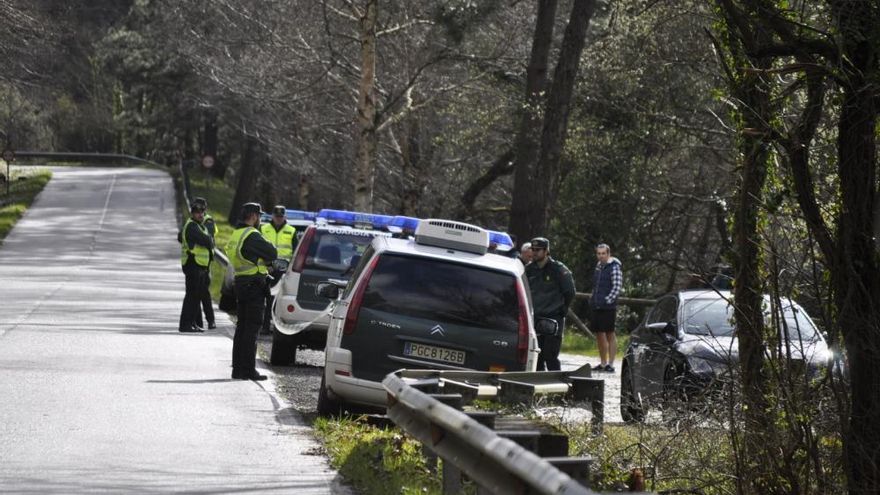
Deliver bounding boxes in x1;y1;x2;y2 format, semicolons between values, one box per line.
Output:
314;418;442;495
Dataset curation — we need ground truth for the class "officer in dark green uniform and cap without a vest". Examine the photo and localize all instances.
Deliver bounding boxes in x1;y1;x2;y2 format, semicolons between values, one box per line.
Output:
526;237;575;371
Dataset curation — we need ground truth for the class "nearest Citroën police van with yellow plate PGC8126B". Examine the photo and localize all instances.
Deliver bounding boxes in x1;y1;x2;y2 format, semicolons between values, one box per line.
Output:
317;219;556;414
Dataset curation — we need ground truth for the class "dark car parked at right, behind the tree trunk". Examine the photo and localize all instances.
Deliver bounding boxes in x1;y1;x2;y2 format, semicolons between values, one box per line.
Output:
620;290;833;422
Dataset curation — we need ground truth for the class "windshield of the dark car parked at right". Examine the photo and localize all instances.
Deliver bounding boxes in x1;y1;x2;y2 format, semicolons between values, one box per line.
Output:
684;298;817;341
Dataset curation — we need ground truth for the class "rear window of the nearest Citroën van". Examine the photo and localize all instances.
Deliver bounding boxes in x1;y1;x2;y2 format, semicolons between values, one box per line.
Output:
363;254;519;333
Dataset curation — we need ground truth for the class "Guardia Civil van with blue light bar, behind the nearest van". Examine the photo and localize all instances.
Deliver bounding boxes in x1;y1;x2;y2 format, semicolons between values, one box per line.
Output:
269;209;393;366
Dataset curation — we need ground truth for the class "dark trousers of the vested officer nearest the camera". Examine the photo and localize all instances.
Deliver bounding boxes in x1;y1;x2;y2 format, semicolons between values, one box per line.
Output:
232;275;268;376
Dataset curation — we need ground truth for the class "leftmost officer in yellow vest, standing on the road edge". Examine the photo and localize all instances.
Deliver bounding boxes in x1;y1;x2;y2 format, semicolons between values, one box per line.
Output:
177;203;214;332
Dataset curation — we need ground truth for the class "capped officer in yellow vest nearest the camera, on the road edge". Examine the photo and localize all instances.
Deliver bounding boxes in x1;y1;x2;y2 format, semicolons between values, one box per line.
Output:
226;203;278;381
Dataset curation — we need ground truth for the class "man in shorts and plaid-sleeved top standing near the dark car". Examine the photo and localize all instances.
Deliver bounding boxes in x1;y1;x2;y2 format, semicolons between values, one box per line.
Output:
590;244;623;372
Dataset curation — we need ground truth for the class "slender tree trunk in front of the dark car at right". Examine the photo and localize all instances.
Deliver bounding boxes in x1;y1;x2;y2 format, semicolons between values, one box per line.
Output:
719;0;775;494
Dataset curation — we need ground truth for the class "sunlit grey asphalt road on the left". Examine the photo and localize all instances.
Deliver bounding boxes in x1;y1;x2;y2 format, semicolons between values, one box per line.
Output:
0;168;348;495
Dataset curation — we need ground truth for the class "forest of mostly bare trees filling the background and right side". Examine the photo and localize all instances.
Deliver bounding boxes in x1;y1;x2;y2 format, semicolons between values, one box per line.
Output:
0;0;880;493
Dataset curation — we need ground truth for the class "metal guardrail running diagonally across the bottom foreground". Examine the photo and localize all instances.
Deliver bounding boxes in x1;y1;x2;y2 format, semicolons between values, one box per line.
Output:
382;370;648;495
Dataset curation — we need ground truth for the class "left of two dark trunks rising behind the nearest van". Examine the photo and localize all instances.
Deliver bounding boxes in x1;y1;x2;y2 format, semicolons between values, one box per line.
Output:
506;0;556;241
